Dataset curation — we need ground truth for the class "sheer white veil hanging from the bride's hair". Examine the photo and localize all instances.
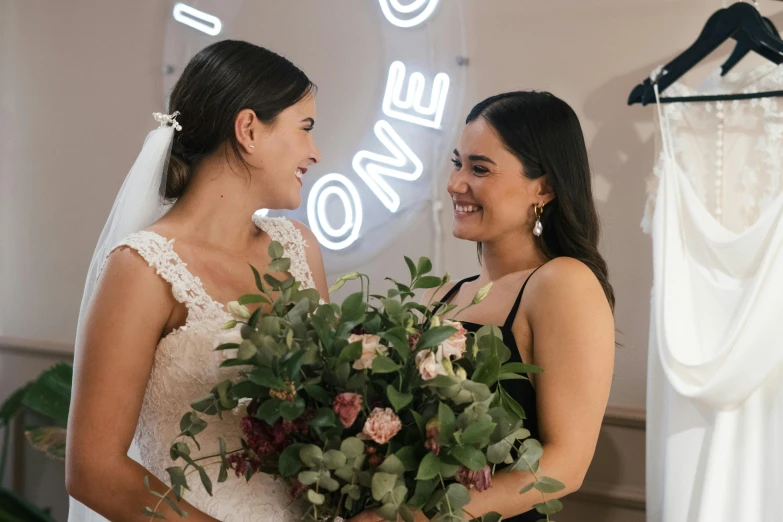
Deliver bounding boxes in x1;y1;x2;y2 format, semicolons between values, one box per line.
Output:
68;112;182;522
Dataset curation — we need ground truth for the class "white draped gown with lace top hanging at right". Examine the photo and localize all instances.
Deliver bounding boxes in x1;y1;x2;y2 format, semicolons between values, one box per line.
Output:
643;66;783;522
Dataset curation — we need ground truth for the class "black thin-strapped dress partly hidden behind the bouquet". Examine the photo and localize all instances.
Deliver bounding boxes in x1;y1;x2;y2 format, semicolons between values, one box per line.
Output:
435;267;546;522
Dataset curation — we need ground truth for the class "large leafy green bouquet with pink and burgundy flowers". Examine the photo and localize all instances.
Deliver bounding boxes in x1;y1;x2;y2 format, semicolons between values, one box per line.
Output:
145;243;563;522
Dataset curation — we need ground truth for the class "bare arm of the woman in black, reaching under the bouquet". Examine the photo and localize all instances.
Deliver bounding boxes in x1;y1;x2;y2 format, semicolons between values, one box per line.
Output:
456;258;615;518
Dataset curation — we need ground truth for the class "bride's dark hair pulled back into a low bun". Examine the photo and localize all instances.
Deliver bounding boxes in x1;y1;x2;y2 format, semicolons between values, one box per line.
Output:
166;40;315;199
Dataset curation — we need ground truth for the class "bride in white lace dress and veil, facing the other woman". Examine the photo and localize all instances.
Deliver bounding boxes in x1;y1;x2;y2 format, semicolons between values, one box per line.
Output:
66;41;328;522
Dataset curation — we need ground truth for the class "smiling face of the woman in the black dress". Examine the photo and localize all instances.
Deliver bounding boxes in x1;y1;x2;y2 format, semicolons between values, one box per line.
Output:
448;117;551;242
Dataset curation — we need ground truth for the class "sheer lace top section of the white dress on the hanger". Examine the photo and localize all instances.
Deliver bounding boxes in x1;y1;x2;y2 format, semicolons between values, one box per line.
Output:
642;64;783;232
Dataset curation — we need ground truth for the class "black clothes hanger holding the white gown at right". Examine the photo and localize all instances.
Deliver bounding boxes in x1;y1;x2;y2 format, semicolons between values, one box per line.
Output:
628;2;783;105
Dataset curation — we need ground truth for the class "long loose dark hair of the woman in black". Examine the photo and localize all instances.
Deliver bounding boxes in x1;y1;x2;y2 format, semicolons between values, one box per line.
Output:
465;91;614;310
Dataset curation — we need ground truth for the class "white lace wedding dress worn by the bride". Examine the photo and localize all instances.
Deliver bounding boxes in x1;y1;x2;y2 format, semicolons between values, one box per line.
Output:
113;218;315;522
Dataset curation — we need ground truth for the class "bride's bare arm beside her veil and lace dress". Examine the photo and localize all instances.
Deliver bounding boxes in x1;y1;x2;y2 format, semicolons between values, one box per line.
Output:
65;248;216;522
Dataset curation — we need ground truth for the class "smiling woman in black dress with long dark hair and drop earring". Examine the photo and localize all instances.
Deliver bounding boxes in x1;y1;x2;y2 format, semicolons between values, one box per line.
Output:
427;92;615;522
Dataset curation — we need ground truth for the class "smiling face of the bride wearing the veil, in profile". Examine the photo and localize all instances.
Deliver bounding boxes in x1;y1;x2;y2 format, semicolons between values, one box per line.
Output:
249;95;321;210
